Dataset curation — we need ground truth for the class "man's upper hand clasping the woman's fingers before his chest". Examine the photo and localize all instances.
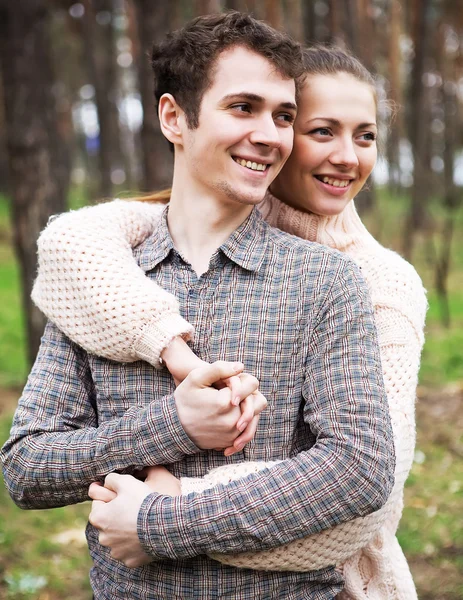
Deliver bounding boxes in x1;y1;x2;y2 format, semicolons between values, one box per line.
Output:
174;361;267;450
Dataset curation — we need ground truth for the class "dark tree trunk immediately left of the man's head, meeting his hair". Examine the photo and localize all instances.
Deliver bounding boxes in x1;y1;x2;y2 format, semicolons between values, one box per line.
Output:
135;0;173;191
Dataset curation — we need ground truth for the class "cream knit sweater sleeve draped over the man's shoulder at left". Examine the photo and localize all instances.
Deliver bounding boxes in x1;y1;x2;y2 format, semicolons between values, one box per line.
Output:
32;200;193;366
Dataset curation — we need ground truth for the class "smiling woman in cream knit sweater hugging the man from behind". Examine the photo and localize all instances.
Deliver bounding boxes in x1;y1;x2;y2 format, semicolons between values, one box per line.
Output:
33;47;426;600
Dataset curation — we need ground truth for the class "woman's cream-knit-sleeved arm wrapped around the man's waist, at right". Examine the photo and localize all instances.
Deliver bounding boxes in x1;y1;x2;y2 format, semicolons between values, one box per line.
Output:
177;261;427;572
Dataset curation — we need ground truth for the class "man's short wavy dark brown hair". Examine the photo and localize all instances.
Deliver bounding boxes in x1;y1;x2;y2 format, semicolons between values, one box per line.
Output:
151;11;303;129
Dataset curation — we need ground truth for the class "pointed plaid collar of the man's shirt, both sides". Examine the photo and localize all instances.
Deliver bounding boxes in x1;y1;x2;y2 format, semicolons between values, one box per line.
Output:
134;207;268;273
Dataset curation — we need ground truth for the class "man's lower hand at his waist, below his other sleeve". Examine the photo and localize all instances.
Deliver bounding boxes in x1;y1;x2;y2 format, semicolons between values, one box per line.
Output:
88;473;153;568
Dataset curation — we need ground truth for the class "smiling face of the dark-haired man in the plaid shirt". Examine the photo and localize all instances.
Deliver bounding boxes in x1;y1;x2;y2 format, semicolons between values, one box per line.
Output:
183;46;296;205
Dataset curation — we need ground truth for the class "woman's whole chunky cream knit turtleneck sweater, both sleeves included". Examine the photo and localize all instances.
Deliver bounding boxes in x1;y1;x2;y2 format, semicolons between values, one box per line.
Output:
32;195;427;600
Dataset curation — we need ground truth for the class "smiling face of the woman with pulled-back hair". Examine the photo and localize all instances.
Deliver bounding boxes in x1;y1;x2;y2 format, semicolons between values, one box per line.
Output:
270;73;377;216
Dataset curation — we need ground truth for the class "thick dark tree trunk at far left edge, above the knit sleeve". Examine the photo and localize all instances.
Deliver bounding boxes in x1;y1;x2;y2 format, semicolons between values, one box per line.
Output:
0;0;69;363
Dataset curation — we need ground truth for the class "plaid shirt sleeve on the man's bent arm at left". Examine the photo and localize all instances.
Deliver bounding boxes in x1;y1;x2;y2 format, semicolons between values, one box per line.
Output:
0;324;199;508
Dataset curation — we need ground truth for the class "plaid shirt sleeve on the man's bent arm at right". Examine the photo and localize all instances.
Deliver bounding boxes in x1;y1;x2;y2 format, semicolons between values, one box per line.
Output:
138;260;395;558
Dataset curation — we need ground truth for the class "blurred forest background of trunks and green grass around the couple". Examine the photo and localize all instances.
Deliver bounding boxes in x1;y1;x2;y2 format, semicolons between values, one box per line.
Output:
0;0;463;600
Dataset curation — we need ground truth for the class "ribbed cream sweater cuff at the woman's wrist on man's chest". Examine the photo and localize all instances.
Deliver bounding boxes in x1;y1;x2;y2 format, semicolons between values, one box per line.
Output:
133;313;194;369
